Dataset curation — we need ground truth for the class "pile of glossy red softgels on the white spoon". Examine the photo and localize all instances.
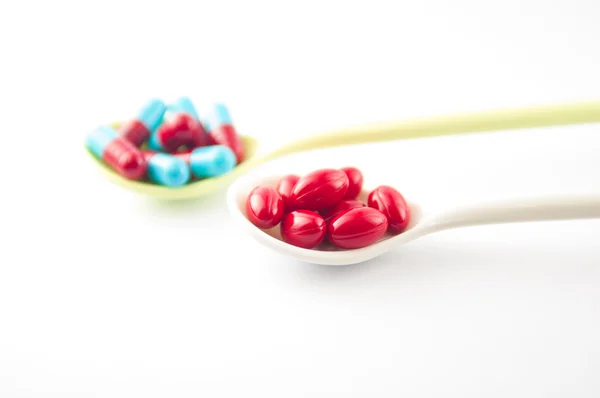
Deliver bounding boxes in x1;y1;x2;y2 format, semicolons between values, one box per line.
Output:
246;167;410;249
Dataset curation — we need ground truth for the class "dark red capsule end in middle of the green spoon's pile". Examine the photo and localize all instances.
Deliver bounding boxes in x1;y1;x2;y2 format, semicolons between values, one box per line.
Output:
156;113;207;152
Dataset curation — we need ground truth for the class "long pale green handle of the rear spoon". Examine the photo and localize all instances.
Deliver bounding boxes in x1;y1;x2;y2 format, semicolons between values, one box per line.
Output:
261;101;600;161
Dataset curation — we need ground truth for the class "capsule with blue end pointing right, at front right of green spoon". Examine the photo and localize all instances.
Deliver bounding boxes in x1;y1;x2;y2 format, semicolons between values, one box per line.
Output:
175;145;236;178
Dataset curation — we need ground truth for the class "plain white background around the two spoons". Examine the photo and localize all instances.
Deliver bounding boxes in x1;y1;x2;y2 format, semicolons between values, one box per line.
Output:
0;0;600;398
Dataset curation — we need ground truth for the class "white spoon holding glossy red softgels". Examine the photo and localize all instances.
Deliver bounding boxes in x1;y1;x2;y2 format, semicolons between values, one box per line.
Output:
227;176;600;265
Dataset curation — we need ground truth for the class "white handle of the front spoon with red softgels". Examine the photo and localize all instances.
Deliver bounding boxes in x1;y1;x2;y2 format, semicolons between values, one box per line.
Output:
428;194;600;232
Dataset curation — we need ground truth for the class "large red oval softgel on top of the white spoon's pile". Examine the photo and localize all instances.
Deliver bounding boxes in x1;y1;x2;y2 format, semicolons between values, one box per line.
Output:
290;169;348;210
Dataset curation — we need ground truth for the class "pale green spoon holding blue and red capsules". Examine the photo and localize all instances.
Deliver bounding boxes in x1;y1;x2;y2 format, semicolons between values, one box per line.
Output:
86;101;600;199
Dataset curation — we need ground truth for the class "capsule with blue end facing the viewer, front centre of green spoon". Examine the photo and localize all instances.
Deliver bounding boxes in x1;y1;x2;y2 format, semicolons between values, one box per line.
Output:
143;151;190;187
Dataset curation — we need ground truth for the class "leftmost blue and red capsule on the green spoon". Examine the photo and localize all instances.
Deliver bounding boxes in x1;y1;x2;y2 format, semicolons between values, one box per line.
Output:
86;126;147;180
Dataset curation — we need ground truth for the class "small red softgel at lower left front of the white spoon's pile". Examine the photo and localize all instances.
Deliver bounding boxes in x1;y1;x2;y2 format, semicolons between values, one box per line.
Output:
281;210;327;249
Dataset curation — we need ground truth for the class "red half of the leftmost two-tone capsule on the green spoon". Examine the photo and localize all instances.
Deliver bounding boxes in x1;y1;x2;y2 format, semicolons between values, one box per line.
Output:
102;137;148;180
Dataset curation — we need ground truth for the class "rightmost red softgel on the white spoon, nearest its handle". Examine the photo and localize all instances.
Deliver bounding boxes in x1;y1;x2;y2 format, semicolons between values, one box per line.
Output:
368;185;410;234
